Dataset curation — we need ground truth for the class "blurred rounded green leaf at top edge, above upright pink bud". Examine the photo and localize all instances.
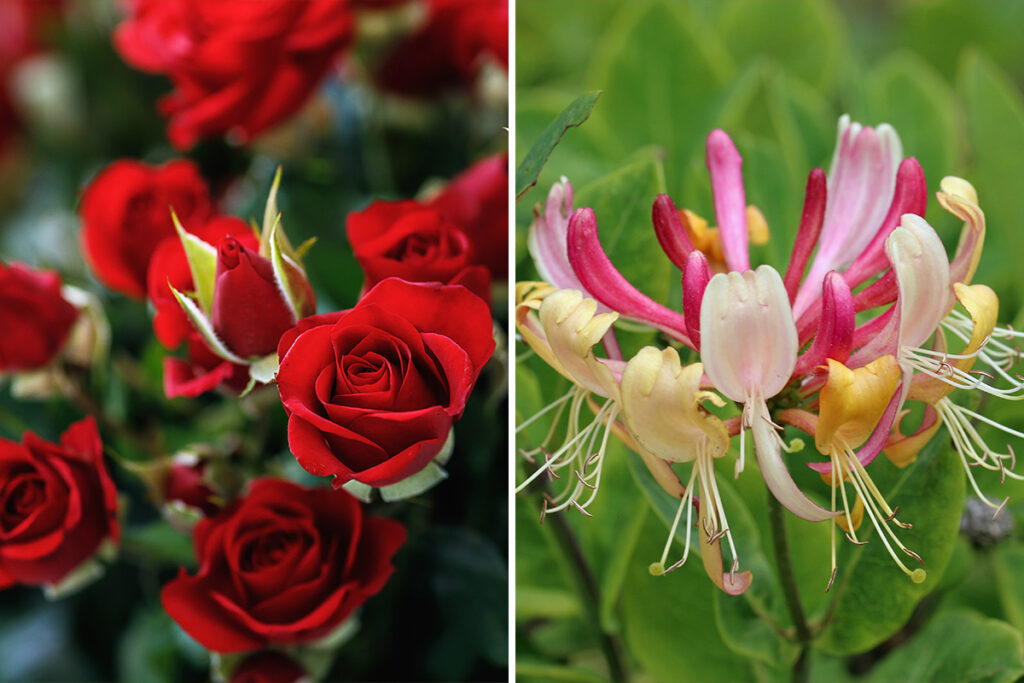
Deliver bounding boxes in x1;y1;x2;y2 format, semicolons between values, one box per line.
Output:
719;0;846;91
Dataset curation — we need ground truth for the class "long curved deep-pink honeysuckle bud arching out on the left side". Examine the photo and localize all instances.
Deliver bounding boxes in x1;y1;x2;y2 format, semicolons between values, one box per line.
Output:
568;208;690;345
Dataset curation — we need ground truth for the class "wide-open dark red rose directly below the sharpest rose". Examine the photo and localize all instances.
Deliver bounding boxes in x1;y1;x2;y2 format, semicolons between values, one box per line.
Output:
161;479;406;652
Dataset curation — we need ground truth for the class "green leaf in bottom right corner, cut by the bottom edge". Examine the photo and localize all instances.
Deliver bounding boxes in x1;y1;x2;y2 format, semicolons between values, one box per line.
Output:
867;609;1024;683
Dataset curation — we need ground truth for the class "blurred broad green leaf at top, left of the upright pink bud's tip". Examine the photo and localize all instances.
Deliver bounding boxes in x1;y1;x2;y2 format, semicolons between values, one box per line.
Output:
588;2;735;187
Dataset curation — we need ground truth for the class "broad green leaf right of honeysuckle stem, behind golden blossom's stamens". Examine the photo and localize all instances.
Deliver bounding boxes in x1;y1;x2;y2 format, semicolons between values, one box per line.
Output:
818;436;965;654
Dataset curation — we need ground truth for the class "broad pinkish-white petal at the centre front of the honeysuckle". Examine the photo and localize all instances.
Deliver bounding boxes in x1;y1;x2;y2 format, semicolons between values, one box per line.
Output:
700;265;797;402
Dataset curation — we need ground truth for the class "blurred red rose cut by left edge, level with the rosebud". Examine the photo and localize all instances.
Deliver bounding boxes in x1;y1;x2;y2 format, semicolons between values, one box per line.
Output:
0;262;78;373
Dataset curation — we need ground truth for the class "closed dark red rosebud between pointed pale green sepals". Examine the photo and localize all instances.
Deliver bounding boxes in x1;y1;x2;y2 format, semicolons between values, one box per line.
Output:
212;238;316;358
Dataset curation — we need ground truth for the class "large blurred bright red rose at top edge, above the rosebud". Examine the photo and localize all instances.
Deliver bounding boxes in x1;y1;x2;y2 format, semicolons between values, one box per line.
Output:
114;0;352;148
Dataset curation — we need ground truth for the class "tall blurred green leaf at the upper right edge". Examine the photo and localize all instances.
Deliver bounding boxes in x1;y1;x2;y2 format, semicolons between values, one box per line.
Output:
957;51;1024;301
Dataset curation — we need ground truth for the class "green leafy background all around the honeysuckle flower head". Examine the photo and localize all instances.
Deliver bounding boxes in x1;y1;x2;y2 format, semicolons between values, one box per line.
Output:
515;0;1024;683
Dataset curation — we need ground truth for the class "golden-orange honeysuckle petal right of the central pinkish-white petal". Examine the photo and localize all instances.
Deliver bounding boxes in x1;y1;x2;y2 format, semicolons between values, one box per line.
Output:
814;354;900;456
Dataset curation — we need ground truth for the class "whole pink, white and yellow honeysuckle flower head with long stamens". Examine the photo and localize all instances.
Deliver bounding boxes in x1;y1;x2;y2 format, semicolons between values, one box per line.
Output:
516;117;1024;594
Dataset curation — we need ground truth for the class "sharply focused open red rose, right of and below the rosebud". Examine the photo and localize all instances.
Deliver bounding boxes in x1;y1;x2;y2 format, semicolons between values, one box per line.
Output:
278;279;495;486
